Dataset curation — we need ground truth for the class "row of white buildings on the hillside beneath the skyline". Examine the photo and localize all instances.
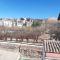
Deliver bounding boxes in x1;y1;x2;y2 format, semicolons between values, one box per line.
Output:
0;18;33;27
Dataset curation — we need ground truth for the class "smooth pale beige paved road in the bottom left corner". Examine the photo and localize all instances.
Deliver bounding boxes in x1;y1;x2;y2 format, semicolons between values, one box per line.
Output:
0;49;19;60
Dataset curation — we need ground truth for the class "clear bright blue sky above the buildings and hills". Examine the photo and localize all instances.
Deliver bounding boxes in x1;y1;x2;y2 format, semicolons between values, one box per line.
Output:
0;0;60;18
